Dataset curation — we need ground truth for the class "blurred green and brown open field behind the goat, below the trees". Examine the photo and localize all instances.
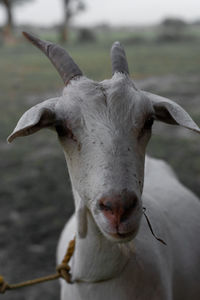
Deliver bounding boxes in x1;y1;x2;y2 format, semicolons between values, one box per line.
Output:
0;31;200;300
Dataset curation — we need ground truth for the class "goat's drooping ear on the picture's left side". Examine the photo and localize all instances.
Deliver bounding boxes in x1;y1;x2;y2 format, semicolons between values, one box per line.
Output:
7;98;58;143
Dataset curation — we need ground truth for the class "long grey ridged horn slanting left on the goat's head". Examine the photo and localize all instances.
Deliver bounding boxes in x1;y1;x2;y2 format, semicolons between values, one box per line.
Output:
23;32;83;85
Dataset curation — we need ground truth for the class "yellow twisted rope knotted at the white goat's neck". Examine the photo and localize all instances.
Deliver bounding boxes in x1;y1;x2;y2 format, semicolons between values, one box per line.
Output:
0;238;75;294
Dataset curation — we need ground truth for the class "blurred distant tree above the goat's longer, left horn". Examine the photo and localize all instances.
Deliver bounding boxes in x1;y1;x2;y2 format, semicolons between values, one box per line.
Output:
61;0;85;42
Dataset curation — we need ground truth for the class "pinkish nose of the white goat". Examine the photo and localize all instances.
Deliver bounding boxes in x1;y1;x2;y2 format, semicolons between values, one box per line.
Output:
99;191;138;227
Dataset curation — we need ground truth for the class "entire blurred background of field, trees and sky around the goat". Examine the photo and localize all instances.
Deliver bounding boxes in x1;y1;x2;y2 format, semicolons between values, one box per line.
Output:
0;0;200;300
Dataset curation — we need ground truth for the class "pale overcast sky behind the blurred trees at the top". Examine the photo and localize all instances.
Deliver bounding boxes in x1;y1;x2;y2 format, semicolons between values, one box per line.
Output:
0;0;200;26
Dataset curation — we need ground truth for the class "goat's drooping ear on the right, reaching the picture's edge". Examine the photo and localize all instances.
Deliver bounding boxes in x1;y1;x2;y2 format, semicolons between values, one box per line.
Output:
143;92;200;133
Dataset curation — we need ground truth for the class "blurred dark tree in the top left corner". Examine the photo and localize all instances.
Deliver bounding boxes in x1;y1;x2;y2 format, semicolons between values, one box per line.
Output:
0;0;32;39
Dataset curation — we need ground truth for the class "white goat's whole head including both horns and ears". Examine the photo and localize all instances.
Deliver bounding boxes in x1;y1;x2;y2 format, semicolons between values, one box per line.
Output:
8;33;200;242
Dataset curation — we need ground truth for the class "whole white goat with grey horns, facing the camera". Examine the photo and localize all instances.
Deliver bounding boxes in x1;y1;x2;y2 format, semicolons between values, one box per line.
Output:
8;33;200;300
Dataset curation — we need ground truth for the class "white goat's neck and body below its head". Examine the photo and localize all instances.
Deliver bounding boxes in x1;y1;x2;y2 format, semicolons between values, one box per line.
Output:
58;156;200;300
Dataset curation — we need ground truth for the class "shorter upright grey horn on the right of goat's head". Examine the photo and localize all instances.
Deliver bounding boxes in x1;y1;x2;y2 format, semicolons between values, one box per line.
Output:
111;42;129;75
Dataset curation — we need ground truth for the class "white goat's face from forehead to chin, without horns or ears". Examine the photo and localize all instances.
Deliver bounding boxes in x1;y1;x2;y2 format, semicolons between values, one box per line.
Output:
56;73;153;241
